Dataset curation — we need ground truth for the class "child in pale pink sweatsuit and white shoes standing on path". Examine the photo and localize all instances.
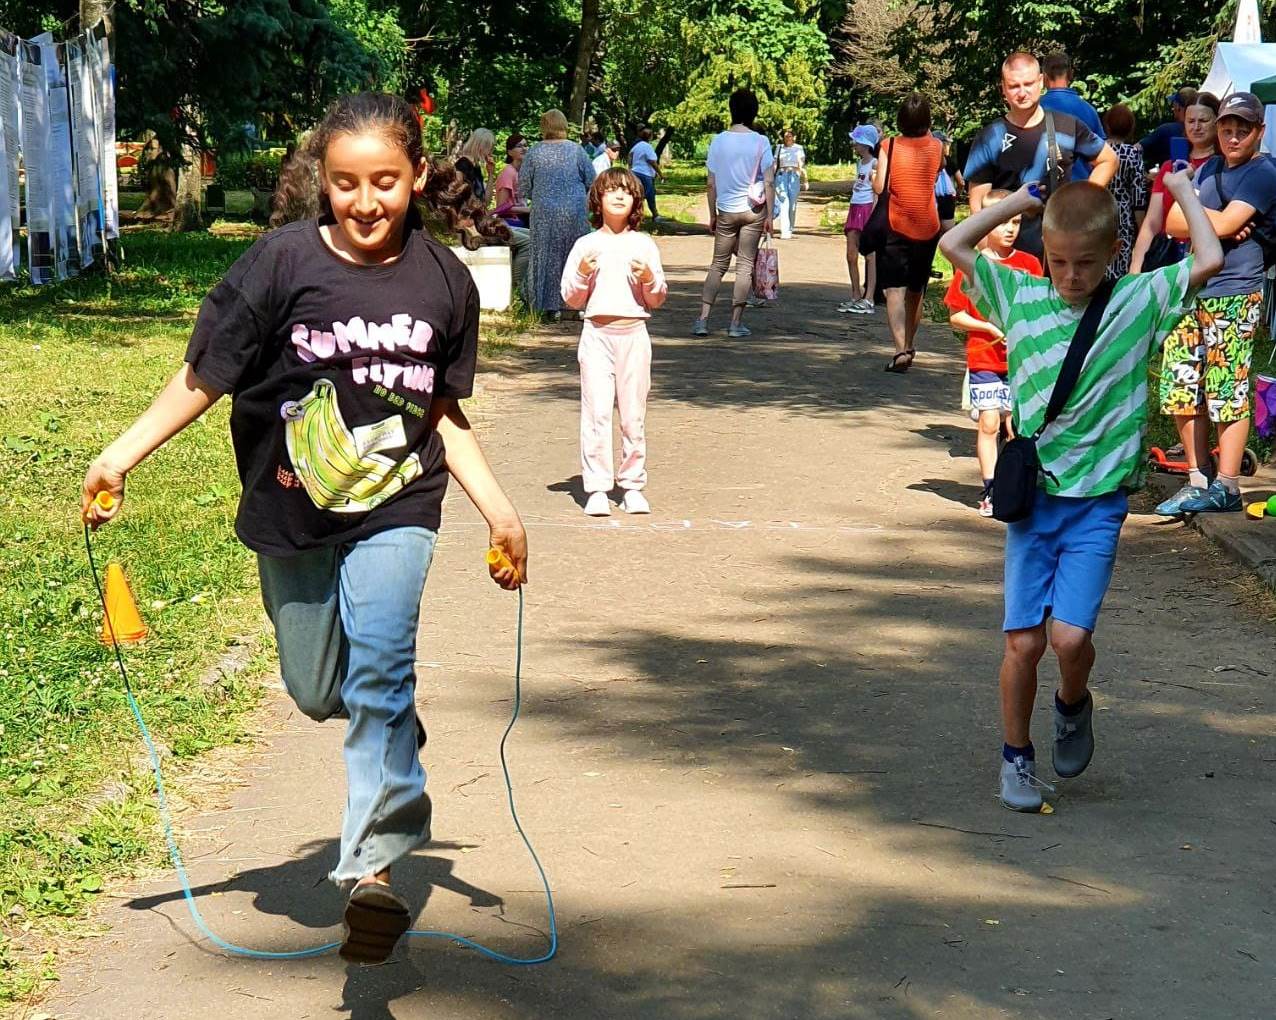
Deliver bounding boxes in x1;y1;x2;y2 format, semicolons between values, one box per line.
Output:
563;167;669;517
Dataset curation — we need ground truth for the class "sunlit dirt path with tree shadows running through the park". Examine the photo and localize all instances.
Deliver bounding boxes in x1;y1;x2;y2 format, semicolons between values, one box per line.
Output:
43;199;1276;1020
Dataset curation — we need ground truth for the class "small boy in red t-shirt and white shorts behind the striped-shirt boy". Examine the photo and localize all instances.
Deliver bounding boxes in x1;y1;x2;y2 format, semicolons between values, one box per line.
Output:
944;190;1041;517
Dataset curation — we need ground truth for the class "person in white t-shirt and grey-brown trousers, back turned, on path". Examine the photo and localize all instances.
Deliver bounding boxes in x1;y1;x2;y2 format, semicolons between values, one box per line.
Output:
692;88;776;337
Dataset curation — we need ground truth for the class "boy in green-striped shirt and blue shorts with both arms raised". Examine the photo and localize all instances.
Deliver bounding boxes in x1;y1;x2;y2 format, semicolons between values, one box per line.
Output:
940;176;1222;811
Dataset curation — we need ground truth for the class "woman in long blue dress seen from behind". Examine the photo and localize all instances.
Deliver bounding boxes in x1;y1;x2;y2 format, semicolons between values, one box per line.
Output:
518;110;595;319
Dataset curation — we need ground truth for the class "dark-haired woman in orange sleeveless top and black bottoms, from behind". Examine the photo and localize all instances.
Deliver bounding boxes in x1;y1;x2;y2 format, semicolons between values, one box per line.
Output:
873;92;944;371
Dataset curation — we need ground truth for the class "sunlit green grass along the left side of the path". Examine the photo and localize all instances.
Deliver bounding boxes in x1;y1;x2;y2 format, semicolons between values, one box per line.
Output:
0;230;531;1007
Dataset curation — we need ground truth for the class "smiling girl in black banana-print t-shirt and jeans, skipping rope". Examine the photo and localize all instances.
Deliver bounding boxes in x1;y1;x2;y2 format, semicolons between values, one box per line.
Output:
82;93;527;963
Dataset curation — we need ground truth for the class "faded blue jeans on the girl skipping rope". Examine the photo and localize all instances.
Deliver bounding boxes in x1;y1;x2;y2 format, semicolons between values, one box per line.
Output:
258;527;438;882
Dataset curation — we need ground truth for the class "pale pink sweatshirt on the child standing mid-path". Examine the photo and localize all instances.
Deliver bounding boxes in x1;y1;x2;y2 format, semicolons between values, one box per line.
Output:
561;230;669;319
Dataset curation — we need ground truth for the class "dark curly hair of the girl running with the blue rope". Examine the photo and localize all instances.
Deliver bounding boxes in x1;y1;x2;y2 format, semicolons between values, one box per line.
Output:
271;92;510;249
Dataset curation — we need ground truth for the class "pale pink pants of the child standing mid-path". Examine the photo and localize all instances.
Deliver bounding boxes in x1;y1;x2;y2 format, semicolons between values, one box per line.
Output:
578;319;651;493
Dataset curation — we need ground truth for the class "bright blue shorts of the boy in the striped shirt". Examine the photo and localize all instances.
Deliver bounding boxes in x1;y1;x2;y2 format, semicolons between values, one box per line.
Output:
1002;490;1129;631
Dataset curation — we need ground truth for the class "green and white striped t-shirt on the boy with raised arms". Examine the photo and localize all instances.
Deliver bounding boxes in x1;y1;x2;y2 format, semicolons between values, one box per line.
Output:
966;254;1196;497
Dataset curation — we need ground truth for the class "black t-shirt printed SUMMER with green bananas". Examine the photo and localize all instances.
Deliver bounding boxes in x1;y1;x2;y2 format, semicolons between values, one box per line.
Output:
186;220;479;557
